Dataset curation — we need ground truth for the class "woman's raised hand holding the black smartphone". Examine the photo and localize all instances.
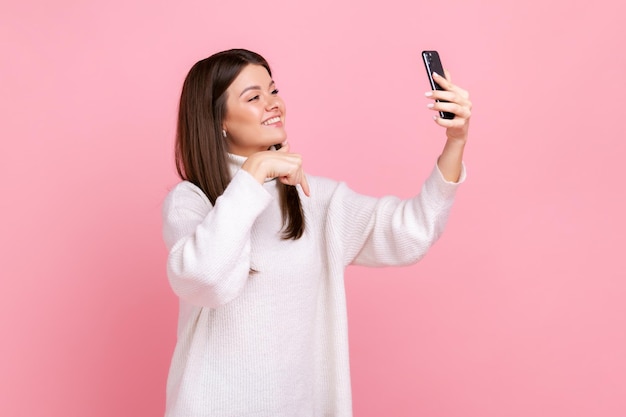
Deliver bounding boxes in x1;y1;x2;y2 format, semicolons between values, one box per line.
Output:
426;70;472;143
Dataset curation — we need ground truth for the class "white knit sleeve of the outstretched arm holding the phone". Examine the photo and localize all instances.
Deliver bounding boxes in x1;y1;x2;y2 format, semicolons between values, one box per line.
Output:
327;162;465;266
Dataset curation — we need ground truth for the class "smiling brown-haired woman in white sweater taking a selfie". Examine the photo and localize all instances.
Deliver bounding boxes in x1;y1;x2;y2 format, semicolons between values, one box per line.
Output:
163;49;471;417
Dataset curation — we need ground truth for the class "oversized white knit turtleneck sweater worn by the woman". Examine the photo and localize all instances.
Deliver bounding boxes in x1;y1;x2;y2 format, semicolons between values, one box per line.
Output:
163;155;465;417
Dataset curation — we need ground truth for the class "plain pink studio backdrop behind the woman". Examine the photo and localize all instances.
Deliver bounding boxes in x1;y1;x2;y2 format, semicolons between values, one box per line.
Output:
0;0;626;417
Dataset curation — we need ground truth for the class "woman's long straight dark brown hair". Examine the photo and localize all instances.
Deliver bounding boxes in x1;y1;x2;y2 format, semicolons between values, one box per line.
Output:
175;49;304;240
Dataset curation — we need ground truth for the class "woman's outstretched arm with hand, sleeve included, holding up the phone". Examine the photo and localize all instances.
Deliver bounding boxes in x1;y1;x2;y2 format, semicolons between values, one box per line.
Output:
330;72;472;266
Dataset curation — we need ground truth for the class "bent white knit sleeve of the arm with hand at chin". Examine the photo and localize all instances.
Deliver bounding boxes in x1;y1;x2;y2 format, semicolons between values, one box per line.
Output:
163;170;272;307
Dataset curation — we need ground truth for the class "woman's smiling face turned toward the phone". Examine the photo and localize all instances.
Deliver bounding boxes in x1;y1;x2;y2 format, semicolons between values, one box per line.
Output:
222;64;287;156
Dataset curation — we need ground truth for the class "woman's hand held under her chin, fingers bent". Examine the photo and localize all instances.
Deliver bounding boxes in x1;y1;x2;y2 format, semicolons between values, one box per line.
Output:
241;142;310;197
